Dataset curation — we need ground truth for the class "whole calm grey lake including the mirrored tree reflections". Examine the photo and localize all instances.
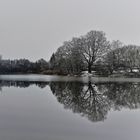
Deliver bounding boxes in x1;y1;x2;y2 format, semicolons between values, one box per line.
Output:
0;75;140;140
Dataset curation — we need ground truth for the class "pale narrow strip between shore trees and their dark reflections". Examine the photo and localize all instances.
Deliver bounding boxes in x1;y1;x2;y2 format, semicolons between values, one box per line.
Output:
0;74;140;83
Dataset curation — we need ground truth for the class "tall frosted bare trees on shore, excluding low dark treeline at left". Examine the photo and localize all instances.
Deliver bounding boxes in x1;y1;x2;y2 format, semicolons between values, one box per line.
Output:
49;31;140;75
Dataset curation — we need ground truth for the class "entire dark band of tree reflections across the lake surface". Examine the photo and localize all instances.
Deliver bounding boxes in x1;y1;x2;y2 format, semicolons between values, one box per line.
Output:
0;81;140;122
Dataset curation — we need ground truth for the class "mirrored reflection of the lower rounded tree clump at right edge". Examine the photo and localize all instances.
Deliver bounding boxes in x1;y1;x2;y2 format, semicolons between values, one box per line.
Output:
102;83;140;110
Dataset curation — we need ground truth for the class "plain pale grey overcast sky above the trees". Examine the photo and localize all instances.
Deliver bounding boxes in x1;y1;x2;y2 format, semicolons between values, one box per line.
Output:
0;0;140;60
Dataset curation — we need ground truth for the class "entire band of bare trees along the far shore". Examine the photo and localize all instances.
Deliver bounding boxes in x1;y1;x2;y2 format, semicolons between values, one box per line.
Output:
0;31;140;76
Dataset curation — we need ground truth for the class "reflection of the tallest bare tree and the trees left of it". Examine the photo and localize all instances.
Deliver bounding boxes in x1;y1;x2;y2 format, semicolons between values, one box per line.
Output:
50;82;111;122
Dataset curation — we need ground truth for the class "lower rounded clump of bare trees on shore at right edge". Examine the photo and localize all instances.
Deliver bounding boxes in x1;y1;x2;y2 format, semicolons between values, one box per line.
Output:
103;45;140;74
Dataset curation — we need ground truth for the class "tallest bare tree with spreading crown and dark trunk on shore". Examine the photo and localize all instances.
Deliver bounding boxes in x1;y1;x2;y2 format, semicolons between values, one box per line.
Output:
79;31;110;73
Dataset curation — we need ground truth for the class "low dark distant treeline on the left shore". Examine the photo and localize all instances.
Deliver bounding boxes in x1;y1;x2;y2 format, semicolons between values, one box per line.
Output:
0;59;49;74
